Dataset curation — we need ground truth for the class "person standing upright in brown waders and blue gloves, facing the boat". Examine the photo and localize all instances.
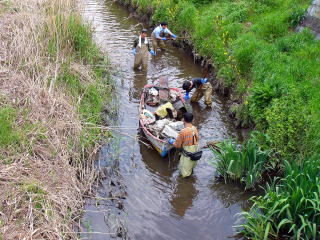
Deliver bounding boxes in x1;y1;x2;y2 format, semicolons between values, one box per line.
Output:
132;29;156;71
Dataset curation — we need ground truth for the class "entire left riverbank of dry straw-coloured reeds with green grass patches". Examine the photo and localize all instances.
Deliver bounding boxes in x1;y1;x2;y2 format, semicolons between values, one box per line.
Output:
0;0;112;240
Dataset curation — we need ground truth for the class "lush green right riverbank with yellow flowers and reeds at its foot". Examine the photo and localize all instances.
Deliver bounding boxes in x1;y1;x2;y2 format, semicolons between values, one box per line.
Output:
120;0;320;239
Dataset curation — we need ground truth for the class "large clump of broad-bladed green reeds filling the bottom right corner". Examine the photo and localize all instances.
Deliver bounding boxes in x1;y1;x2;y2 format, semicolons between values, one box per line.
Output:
238;159;320;240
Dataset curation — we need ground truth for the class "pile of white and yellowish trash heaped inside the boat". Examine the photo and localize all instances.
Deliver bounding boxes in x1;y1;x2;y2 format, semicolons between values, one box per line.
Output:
140;86;187;139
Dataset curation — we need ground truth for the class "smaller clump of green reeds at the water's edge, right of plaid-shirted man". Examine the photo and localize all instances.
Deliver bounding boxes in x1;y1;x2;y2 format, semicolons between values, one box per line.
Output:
212;140;269;189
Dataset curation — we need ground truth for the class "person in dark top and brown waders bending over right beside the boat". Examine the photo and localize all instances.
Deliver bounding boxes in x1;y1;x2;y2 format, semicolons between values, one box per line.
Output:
182;78;212;106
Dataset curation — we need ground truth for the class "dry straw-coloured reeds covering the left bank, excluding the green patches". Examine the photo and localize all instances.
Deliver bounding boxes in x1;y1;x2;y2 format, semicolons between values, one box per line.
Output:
0;0;102;240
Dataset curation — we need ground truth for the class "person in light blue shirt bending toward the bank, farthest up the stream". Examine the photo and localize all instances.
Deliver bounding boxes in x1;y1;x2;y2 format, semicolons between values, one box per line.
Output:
151;22;177;52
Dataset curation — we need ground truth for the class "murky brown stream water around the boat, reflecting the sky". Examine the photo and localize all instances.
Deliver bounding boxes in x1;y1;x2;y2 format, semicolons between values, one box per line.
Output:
81;0;258;240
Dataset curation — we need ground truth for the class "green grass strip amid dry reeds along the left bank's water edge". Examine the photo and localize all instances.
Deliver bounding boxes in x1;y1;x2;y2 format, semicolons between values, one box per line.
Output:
54;15;113;147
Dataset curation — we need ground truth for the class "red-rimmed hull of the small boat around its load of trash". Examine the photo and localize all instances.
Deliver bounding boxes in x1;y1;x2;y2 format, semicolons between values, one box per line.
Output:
139;85;185;157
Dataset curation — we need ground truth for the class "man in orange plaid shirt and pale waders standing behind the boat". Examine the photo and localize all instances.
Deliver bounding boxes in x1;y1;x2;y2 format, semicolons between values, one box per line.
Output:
168;112;199;177
